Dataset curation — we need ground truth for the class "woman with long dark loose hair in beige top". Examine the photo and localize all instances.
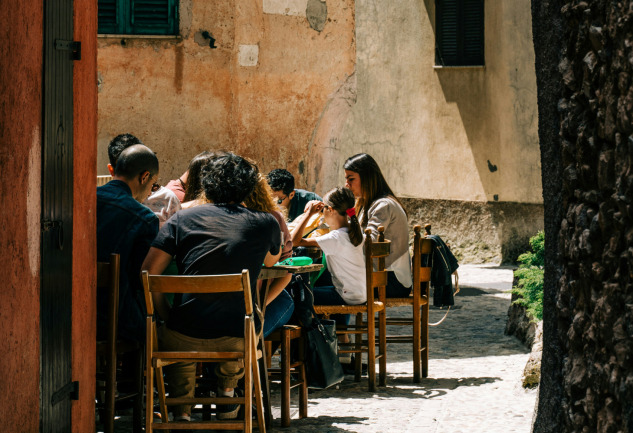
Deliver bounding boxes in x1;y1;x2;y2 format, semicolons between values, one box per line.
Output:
343;153;413;298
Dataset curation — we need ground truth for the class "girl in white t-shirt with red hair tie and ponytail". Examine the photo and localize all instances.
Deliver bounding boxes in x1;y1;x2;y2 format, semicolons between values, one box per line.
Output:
292;188;367;305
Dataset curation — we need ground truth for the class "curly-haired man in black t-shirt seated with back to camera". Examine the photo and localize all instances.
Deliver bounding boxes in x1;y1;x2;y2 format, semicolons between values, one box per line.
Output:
143;153;281;420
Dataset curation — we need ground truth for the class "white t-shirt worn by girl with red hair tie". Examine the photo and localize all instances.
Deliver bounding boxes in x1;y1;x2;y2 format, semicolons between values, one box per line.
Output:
315;227;367;305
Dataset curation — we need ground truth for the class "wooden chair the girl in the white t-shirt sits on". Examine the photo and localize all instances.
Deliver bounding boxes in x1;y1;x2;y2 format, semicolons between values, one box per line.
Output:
314;226;391;392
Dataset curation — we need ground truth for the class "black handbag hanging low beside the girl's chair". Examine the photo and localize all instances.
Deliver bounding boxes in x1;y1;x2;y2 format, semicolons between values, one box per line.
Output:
305;317;345;389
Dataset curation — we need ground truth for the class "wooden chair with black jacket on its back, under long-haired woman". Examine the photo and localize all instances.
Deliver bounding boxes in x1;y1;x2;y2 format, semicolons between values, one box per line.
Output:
379;225;432;383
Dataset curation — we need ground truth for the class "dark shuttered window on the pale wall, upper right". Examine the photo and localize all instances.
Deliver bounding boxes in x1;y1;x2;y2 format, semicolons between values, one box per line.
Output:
435;0;484;66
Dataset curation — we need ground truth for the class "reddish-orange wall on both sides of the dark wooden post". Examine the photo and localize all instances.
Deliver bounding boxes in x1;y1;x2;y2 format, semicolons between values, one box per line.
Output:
0;0;97;432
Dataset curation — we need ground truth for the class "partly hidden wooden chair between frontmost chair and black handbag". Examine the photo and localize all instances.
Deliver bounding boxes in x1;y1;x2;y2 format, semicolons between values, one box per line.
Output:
265;325;308;427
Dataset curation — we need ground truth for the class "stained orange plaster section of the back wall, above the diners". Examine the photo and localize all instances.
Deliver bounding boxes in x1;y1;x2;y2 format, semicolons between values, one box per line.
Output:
97;0;356;186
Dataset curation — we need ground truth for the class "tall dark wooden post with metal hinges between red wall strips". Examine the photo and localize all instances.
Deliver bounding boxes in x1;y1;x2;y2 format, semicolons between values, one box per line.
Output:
40;0;80;433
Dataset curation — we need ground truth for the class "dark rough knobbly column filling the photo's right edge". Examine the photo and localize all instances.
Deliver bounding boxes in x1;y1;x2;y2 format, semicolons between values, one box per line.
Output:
534;0;633;433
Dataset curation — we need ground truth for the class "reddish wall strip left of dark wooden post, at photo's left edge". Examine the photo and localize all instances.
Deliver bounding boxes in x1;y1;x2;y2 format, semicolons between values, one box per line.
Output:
0;1;43;432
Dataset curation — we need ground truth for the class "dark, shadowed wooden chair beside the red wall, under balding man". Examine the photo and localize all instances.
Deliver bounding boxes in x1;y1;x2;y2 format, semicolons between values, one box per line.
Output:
96;254;143;433
